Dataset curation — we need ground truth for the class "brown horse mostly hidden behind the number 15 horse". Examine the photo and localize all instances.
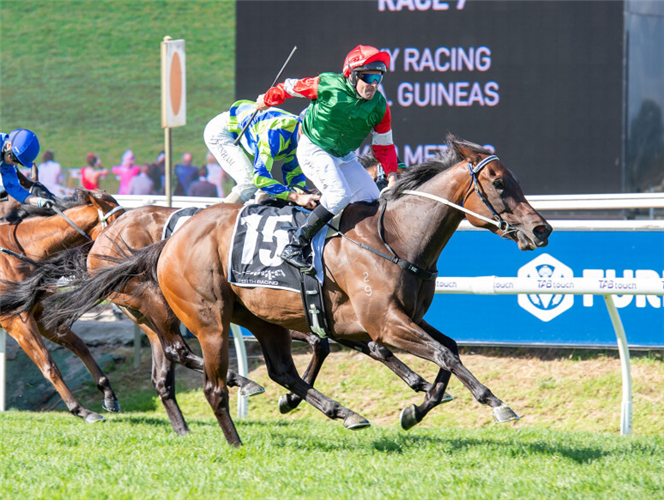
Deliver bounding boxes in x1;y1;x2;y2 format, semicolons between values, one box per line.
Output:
18;206;440;434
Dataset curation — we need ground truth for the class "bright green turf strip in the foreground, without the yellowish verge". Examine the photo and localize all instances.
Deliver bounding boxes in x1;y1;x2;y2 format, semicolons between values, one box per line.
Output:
0;412;664;499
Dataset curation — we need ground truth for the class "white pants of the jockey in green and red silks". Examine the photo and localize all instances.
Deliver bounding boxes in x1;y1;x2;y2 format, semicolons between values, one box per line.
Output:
297;134;380;215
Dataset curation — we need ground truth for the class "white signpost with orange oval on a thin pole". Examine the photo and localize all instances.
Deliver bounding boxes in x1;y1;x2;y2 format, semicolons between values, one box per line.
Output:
161;36;187;207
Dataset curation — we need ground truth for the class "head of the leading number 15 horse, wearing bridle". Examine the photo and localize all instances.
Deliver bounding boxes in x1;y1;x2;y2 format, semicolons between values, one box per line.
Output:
448;138;552;250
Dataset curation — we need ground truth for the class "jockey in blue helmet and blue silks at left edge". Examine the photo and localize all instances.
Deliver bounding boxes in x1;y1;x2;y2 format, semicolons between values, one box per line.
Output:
0;128;53;207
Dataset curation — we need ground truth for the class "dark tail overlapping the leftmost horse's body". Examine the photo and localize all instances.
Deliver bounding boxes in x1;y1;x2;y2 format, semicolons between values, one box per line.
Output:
0;243;92;317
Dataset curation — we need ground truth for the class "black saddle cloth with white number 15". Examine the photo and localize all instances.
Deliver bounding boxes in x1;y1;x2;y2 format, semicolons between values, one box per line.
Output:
228;204;326;293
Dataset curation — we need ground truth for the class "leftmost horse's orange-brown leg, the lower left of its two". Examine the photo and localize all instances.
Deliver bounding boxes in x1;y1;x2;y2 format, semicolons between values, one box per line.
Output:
2;315;106;424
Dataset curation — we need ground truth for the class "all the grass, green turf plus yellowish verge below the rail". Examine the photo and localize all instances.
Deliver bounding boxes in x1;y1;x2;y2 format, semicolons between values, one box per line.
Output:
0;350;664;500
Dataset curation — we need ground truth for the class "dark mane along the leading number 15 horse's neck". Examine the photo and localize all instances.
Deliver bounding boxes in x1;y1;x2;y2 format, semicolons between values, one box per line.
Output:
380;134;492;201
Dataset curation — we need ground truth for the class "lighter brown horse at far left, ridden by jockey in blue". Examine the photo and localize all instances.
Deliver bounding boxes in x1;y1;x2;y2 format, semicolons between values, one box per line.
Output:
0;190;121;423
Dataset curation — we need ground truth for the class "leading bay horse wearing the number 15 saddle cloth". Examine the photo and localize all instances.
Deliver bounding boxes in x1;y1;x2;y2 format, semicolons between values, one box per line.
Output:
44;136;551;446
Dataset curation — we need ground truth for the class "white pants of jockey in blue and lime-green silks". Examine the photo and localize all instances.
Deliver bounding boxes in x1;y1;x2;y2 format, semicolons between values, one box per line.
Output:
203;111;258;201
